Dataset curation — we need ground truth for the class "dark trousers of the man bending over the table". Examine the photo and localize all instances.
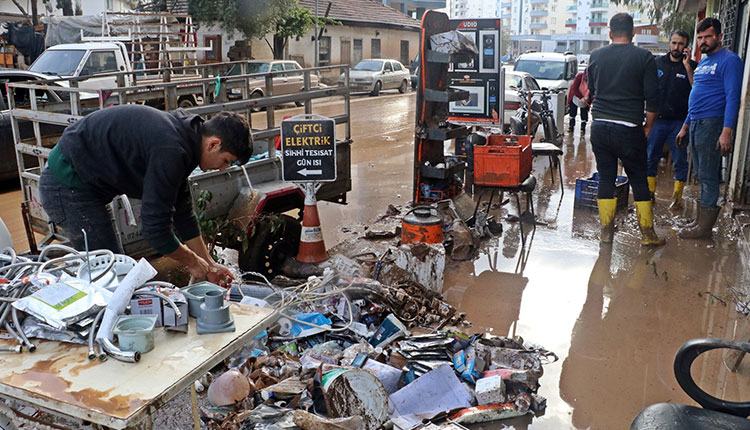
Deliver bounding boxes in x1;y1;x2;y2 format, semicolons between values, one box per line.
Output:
39;168;122;253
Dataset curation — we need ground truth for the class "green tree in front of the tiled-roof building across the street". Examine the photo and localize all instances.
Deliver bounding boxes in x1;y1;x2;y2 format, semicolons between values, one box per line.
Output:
188;0;297;39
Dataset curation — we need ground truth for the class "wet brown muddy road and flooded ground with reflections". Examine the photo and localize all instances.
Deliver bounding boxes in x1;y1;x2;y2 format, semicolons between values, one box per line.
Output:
0;92;750;430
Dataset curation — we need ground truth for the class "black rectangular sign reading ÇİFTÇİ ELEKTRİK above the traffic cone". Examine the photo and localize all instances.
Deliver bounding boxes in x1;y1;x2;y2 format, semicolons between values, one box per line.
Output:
281;115;336;182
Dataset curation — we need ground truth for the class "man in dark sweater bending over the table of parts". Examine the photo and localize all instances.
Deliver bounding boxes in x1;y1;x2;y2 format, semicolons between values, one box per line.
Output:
39;105;251;282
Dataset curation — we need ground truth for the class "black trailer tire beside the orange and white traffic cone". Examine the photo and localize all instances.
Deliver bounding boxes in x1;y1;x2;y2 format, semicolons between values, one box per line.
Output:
238;215;302;279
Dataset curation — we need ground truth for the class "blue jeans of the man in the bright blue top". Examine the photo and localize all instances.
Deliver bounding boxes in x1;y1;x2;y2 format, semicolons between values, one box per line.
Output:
690;117;724;207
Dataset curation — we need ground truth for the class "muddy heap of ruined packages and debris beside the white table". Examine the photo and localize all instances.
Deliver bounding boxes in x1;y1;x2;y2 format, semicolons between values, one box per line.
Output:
206;266;556;430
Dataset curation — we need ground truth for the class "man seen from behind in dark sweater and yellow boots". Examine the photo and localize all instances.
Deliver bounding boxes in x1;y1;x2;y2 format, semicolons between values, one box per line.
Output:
588;13;664;246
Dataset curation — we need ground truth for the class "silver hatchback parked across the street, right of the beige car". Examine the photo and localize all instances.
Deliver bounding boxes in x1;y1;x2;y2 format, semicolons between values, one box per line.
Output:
346;59;411;96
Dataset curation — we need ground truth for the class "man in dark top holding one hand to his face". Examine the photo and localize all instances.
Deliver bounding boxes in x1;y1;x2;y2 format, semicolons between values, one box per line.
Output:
648;30;698;211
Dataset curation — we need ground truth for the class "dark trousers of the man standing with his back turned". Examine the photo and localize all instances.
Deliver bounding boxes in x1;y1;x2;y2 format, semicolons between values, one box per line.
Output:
591;121;651;202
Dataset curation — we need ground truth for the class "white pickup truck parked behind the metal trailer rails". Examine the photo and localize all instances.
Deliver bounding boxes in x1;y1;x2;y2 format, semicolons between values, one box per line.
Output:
29;42;201;108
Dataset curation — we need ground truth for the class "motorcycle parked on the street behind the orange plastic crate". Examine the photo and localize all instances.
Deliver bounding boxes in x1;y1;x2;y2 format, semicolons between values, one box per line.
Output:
510;89;564;144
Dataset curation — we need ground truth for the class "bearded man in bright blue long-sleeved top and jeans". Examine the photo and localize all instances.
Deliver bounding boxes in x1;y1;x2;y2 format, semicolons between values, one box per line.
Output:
676;18;743;239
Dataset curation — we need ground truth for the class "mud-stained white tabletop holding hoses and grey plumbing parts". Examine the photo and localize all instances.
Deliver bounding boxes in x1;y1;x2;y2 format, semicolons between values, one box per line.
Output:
0;303;275;429
